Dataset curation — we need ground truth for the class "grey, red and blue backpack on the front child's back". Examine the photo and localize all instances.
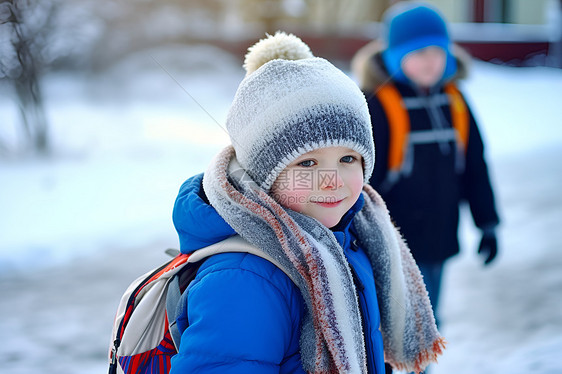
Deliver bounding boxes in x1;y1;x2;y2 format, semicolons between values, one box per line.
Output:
109;235;289;374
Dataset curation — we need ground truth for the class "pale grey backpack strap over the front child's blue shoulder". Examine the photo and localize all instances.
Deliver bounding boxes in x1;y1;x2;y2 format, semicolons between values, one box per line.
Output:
166;235;296;350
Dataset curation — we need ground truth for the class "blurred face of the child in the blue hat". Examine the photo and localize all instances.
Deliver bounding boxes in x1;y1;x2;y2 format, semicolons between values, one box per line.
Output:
402;46;447;88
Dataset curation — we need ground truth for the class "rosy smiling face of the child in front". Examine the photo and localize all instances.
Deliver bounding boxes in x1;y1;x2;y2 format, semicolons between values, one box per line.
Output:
271;147;363;228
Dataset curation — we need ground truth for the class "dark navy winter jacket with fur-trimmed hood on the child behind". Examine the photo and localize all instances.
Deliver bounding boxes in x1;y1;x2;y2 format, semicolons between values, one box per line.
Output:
353;43;499;263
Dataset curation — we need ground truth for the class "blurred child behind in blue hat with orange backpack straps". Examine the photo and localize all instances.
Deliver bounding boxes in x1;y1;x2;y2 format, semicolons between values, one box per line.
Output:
352;1;499;328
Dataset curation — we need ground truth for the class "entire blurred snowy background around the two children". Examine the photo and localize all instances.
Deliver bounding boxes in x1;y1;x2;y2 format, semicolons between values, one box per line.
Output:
0;0;562;374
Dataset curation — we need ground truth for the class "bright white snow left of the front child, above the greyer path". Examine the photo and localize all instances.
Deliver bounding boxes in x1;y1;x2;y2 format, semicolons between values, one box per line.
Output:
0;48;238;269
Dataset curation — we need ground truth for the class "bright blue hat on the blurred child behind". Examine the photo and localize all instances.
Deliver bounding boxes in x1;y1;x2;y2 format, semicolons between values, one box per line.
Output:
382;2;457;82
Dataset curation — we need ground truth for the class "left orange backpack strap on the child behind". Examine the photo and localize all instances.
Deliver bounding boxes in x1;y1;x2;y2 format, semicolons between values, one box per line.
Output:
375;83;410;171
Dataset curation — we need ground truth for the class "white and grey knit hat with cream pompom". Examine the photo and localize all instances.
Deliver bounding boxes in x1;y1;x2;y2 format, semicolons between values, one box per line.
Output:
226;32;375;191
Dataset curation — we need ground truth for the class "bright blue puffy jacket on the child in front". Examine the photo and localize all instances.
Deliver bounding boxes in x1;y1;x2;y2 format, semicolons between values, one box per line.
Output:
170;174;384;374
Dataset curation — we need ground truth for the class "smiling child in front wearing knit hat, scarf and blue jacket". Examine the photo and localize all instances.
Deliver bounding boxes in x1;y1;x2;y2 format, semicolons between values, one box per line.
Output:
171;33;444;374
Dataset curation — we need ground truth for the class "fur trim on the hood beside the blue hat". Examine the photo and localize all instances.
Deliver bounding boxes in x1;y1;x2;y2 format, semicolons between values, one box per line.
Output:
351;40;471;91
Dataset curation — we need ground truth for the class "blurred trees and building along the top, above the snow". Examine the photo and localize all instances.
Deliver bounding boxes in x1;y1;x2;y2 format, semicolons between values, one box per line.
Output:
0;0;562;158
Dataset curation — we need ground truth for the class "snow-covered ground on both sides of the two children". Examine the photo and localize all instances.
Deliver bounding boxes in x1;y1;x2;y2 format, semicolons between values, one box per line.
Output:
0;47;562;374
